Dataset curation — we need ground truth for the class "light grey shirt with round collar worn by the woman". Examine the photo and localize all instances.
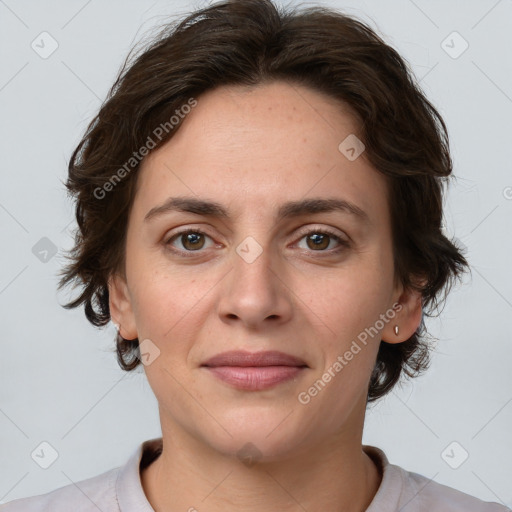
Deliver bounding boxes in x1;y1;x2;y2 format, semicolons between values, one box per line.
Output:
0;438;511;512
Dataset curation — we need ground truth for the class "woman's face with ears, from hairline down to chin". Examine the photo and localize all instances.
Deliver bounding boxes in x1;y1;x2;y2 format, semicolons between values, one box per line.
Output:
110;82;421;460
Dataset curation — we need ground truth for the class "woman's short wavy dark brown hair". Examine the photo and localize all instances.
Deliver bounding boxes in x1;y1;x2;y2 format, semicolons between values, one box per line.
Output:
59;0;469;402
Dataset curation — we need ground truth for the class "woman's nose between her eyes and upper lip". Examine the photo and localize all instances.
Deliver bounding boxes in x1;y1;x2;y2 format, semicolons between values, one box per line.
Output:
218;237;293;330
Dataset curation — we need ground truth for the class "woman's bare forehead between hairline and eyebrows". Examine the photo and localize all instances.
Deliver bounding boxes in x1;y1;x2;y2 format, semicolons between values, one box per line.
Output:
135;82;386;224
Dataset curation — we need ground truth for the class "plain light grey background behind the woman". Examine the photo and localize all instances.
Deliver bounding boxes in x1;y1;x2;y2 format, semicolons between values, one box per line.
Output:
0;0;512;506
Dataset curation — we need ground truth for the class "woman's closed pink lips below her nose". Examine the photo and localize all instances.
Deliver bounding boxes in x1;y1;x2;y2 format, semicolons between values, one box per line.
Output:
202;350;308;391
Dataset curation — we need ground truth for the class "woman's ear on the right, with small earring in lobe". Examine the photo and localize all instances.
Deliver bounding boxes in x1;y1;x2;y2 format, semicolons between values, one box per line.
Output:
381;279;427;343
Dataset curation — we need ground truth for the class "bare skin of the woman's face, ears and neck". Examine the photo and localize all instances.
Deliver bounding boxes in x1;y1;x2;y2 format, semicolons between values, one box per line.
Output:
109;81;421;512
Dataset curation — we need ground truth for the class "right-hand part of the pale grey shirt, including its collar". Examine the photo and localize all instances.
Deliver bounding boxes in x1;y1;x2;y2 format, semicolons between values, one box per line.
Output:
363;445;511;512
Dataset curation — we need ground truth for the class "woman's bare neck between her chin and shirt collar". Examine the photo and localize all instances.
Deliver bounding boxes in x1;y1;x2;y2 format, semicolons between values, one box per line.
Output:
141;424;382;512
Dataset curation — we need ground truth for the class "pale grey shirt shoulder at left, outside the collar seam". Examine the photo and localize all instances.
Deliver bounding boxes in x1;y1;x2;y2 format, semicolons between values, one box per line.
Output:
0;468;120;512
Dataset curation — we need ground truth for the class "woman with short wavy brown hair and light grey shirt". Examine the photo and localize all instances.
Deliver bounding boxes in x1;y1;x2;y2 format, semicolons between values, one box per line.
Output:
4;0;506;512
